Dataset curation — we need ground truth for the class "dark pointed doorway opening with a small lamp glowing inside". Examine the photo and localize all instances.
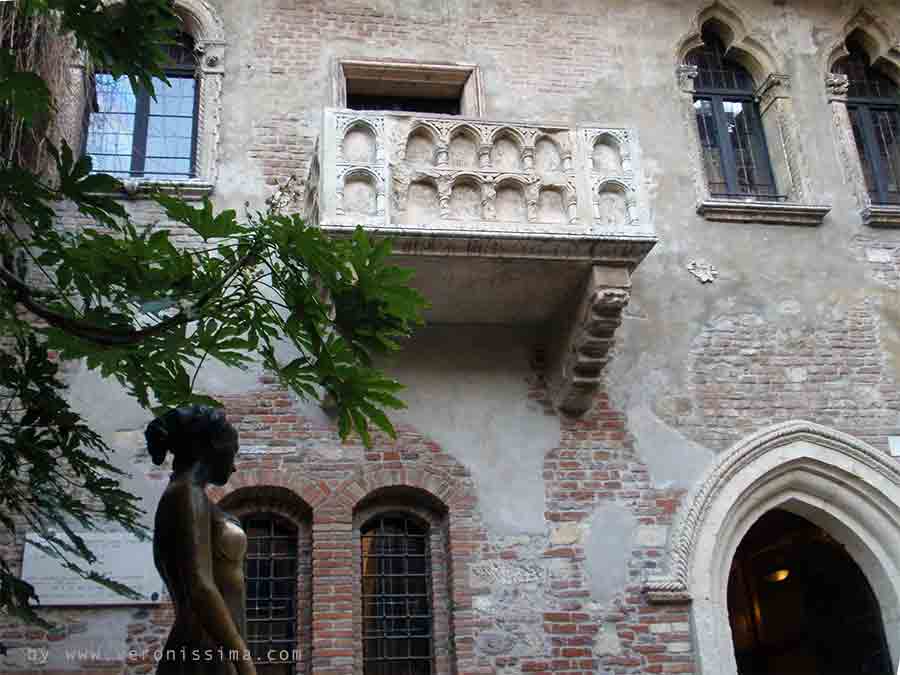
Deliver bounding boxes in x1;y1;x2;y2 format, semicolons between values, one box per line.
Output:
728;509;891;675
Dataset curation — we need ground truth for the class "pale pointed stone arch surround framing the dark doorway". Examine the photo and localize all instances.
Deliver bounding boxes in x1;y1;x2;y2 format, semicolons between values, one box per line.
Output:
645;421;900;675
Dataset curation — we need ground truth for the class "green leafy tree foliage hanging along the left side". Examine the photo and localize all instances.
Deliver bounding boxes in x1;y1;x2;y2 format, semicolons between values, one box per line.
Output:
0;0;425;656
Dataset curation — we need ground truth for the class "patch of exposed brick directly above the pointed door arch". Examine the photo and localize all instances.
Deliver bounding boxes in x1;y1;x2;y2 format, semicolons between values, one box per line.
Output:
657;301;900;450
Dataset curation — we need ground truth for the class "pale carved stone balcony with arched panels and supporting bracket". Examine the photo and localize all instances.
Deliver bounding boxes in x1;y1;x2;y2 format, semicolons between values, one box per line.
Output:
306;109;656;414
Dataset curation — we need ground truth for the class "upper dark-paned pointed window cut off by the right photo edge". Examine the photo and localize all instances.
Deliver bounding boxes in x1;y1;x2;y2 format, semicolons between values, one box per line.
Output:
832;41;900;204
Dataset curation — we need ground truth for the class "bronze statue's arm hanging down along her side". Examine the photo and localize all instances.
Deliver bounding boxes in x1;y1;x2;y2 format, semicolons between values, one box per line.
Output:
172;485;256;675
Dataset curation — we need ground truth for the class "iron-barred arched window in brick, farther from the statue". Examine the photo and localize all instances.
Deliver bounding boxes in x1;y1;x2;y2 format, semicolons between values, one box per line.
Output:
360;513;433;675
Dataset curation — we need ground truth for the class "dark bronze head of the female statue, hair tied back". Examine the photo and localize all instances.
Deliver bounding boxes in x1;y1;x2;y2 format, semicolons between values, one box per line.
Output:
144;405;238;485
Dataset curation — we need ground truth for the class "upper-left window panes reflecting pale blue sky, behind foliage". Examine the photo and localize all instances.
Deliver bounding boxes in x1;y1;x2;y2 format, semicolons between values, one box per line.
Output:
85;33;198;180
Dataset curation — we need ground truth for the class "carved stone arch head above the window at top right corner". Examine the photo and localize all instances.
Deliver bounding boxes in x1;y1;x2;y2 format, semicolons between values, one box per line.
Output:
822;6;900;86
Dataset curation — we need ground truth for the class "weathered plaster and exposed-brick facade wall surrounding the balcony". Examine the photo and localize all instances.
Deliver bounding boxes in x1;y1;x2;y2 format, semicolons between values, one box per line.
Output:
0;0;900;673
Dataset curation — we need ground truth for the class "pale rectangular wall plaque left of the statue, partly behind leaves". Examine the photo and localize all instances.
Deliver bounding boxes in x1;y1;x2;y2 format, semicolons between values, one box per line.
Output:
22;532;163;607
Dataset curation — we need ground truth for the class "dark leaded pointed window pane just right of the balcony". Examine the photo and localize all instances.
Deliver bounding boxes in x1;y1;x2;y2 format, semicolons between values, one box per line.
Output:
686;30;776;199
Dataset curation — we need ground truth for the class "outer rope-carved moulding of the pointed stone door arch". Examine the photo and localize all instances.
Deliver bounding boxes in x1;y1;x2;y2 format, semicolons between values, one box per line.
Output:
644;420;900;603
